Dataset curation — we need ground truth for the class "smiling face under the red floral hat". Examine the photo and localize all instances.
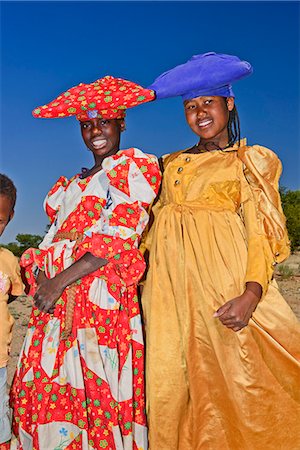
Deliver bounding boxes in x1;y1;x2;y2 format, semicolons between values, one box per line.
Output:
80;119;125;160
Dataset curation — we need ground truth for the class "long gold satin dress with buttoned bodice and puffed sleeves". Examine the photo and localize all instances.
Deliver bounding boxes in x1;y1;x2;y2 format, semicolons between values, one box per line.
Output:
142;140;300;450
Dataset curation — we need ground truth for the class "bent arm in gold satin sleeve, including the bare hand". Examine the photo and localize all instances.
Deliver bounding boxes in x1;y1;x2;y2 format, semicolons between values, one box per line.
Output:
214;146;289;331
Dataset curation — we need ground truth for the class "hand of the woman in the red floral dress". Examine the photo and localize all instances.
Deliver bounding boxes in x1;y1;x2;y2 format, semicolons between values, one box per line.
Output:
33;271;65;314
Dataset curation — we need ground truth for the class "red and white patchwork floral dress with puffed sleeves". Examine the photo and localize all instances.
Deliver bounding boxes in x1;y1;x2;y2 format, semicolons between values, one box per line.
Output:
11;148;160;450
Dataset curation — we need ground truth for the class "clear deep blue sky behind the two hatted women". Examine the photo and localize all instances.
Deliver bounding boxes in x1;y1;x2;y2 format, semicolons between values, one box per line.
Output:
0;1;300;242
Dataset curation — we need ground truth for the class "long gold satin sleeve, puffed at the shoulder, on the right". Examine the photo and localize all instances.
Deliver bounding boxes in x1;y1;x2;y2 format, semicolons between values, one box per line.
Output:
238;145;290;293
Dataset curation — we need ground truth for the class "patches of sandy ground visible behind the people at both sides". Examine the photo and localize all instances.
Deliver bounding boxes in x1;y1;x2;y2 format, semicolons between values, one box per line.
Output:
8;252;300;383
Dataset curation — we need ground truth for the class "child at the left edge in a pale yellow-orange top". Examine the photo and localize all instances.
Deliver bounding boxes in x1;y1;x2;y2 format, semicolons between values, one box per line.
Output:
0;174;23;450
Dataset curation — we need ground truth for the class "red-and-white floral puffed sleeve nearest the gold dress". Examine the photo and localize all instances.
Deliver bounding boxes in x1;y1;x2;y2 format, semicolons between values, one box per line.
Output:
78;148;161;281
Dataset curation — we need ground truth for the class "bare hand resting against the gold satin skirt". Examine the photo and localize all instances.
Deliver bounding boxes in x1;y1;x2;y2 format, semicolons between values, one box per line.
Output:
214;288;261;331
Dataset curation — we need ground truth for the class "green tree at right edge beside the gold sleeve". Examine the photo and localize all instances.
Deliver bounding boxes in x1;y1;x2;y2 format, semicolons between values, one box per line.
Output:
280;187;300;251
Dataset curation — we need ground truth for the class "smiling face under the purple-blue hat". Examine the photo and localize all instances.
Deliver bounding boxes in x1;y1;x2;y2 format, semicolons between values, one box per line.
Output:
184;96;234;146
